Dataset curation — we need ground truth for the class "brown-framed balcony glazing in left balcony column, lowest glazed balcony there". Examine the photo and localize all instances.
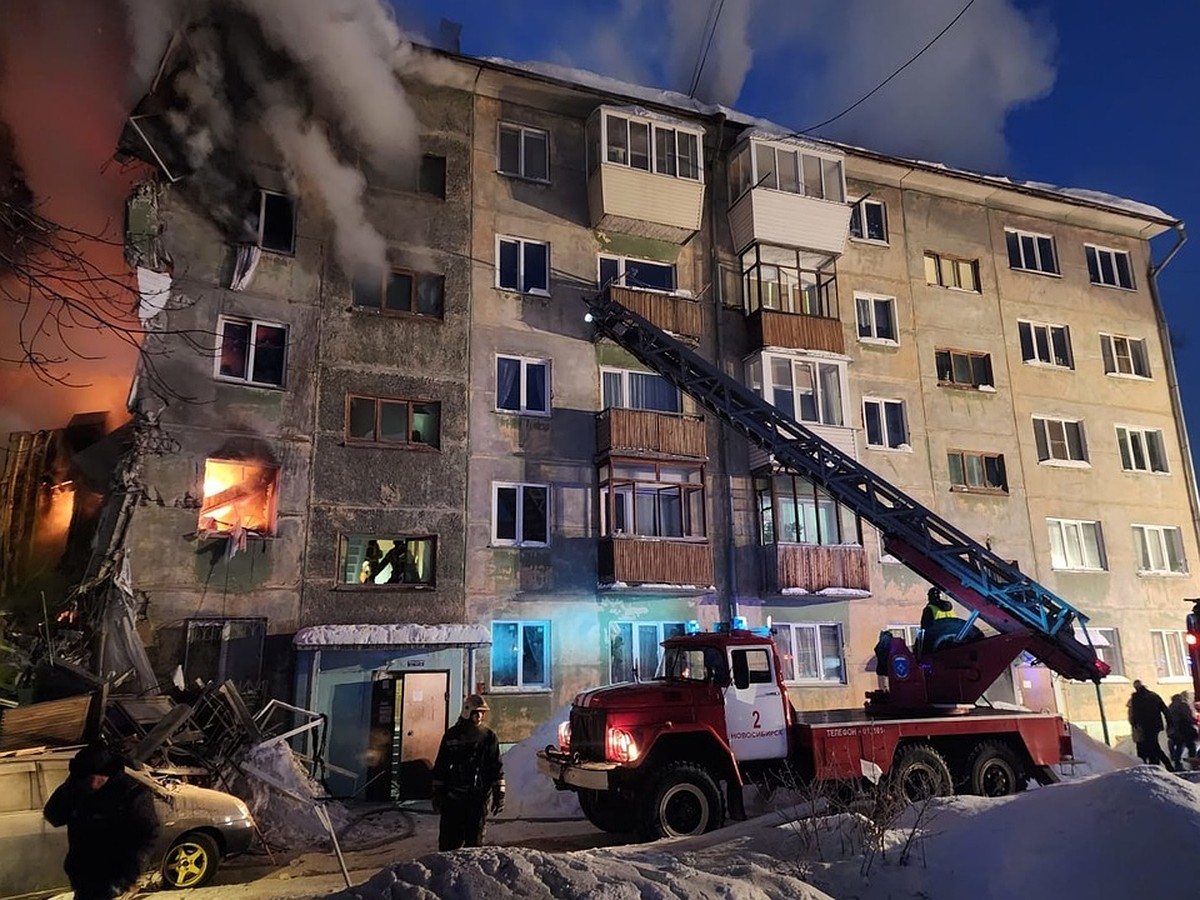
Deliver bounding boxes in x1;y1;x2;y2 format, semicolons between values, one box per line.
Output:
600;460;706;538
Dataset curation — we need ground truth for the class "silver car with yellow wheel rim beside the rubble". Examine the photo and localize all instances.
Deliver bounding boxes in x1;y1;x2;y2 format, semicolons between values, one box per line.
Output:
0;748;254;898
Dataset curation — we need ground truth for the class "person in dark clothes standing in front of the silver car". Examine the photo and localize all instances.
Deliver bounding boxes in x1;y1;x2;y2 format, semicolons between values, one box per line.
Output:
42;744;158;900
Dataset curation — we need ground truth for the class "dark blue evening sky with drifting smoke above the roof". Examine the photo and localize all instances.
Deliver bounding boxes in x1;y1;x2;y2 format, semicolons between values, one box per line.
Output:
396;0;1200;440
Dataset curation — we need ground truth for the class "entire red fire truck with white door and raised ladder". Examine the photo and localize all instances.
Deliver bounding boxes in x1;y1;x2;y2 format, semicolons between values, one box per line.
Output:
538;292;1104;838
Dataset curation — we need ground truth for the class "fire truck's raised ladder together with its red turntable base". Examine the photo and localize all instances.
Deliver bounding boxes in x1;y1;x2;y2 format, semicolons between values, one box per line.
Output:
584;290;1109;713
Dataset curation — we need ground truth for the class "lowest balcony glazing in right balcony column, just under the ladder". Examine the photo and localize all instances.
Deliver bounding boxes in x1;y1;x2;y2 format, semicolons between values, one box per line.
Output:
754;475;863;547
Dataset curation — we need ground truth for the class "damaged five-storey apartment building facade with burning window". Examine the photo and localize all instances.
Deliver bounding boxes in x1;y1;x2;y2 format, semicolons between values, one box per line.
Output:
98;33;1200;798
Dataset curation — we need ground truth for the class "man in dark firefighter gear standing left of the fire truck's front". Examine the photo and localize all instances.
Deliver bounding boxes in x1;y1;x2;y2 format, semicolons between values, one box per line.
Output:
433;694;504;850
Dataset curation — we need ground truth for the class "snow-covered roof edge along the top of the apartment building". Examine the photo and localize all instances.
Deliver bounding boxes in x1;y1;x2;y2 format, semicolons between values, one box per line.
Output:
472;56;1180;227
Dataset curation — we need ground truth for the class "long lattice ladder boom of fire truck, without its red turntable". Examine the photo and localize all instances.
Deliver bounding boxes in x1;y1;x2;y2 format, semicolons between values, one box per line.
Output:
587;292;1109;682
